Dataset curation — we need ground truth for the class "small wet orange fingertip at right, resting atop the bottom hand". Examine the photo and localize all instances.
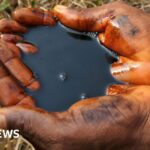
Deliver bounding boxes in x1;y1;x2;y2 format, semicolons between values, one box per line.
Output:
106;84;131;95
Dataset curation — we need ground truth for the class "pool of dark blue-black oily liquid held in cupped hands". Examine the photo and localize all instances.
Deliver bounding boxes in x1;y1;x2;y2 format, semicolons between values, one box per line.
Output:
23;25;117;111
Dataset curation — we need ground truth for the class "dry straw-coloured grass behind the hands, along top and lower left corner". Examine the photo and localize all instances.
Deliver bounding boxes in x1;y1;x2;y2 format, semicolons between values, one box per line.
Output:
0;0;150;150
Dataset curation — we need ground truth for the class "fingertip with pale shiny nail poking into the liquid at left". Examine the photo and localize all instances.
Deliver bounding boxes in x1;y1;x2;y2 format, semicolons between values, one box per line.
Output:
16;43;38;54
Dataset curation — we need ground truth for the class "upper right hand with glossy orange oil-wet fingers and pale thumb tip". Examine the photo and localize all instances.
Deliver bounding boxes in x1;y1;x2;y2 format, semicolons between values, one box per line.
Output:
54;2;150;85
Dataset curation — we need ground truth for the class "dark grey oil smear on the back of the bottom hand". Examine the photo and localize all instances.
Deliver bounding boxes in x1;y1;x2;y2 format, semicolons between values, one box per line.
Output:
81;96;132;123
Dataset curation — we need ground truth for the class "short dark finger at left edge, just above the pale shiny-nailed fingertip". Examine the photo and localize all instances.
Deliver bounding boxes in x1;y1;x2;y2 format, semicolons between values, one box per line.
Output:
0;34;23;43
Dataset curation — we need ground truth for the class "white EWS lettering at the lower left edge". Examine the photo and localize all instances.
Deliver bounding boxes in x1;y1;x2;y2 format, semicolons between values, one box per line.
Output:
0;129;20;139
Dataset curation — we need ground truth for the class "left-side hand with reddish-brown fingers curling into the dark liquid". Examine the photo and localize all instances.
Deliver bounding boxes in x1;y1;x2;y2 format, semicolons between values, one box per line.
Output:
0;8;55;106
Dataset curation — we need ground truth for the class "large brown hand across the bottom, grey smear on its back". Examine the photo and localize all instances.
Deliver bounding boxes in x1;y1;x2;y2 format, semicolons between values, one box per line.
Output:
0;86;150;150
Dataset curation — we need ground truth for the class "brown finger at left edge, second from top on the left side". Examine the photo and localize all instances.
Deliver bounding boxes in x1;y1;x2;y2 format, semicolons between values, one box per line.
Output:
0;18;27;33
